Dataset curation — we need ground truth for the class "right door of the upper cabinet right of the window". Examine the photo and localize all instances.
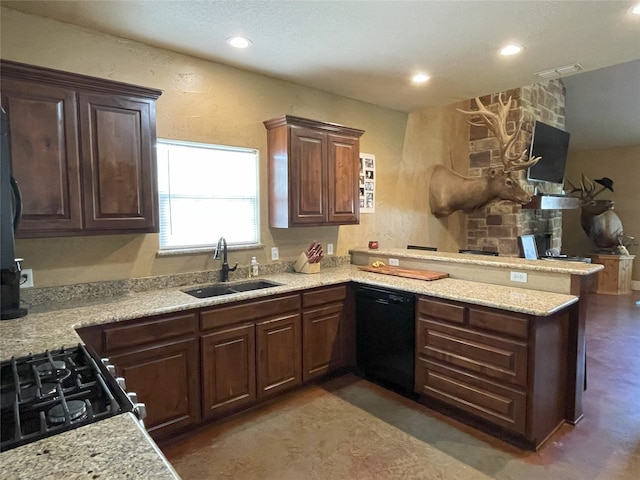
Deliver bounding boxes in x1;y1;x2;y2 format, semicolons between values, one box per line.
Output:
327;135;360;225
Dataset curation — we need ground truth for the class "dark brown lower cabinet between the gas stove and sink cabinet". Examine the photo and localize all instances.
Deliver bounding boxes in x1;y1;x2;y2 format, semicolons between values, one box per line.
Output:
78;311;201;439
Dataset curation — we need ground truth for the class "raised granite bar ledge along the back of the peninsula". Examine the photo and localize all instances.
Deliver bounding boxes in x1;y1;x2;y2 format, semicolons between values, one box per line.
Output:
349;248;604;275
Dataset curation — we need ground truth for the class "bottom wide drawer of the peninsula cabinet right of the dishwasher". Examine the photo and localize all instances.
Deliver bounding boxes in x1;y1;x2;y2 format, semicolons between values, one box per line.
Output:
416;359;527;434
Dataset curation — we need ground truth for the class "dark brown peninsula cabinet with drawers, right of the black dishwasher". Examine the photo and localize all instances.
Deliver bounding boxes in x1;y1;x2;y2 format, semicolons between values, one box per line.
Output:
415;297;570;449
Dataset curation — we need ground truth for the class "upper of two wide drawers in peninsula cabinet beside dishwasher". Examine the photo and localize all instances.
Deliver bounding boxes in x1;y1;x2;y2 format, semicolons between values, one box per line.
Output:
416;319;527;387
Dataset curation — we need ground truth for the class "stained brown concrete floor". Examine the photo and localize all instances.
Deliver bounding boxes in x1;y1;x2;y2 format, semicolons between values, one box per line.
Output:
161;292;640;480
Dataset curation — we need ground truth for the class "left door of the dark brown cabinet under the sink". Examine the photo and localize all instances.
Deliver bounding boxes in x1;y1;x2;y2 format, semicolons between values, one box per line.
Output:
201;325;256;418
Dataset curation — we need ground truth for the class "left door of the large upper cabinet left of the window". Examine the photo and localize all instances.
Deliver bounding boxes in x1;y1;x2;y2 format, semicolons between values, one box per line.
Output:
2;78;82;238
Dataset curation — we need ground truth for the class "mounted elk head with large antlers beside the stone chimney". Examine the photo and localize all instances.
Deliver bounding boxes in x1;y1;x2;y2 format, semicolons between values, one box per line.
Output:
429;97;540;218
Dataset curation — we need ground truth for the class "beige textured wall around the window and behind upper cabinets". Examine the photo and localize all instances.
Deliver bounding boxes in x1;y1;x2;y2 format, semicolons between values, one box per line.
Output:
0;8;468;287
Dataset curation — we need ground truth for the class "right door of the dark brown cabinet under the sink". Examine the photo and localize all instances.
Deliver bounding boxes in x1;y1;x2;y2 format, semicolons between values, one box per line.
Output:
256;313;302;398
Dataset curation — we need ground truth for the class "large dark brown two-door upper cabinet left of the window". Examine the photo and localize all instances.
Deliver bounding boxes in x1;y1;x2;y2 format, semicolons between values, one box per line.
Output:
0;60;162;238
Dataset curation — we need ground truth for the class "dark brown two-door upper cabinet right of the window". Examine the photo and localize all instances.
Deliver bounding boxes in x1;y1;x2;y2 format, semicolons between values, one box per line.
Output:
264;115;364;228
